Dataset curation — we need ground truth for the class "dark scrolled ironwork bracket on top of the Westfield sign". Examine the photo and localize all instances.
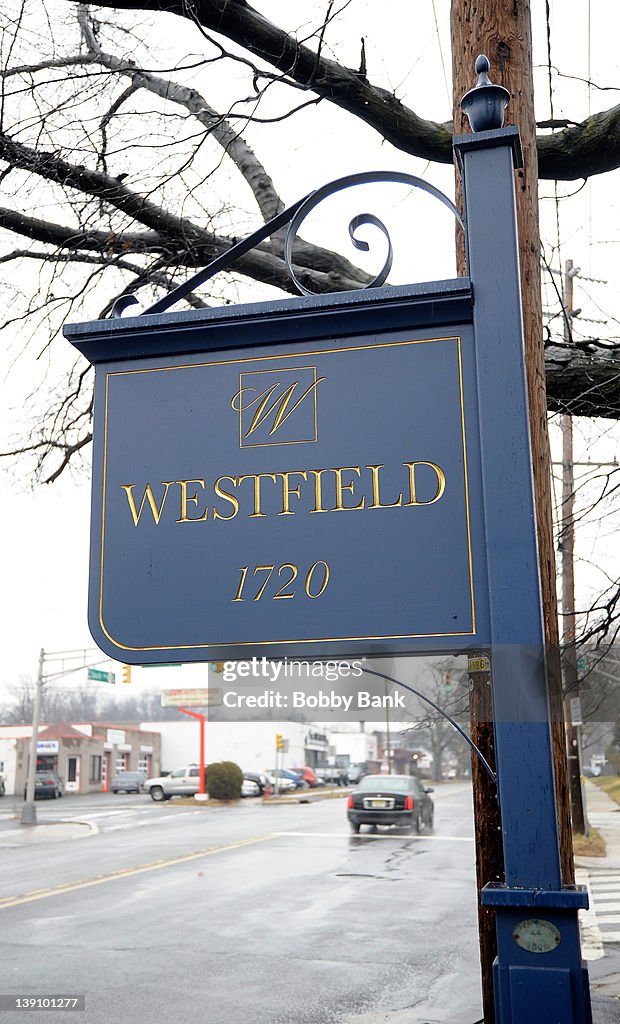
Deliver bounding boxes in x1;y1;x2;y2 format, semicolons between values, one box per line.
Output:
111;171;464;317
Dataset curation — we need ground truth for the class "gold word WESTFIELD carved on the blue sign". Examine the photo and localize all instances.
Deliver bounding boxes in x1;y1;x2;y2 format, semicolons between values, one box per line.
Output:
121;461;447;526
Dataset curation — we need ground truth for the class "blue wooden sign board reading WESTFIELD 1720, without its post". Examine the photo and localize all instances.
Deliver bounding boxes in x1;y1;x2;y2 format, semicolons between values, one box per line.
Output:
68;282;488;664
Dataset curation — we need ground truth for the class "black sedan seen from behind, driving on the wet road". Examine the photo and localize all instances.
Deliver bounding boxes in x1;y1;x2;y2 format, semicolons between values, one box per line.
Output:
346;775;433;833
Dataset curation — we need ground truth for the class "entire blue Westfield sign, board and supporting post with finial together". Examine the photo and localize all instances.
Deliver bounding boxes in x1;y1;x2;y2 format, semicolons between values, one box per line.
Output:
66;58;591;1024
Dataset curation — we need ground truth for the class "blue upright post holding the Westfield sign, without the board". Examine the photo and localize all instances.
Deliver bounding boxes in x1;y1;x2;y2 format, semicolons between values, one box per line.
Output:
454;128;591;1024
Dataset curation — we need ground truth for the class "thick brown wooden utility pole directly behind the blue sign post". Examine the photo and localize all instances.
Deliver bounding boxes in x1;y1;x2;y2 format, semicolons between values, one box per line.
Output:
451;0;574;1024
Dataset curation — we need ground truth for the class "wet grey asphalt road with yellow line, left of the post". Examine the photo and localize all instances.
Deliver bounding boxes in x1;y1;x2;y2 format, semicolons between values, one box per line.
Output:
0;785;482;1024
